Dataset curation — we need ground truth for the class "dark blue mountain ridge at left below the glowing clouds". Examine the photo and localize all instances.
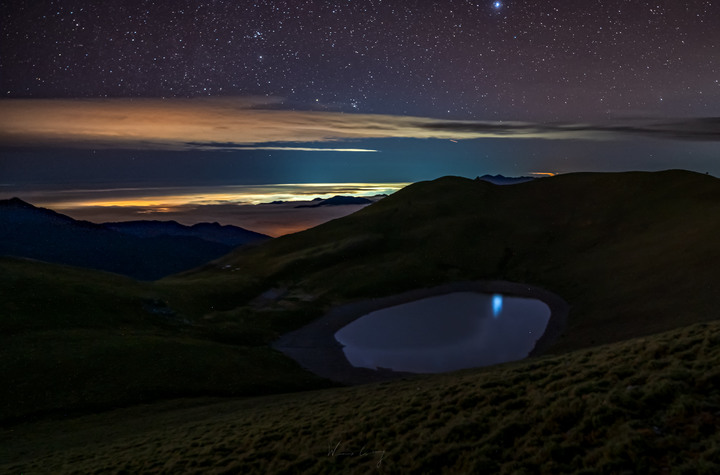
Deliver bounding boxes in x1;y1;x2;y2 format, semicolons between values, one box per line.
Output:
0;198;270;280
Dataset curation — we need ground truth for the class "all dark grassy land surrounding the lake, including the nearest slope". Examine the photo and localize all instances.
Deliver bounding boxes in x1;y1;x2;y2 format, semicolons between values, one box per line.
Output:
0;171;720;473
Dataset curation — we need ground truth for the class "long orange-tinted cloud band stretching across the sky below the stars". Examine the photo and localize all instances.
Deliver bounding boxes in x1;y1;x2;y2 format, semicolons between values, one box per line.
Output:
0;98;720;152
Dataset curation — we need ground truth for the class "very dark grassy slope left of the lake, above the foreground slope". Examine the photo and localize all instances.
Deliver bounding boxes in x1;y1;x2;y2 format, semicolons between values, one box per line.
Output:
0;259;324;421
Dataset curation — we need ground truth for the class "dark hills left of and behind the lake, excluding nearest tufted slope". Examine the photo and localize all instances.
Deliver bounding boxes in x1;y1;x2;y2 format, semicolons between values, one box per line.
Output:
0;171;720;426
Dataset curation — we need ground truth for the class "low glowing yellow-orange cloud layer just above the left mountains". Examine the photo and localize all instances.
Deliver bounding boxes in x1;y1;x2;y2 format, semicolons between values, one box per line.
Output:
7;183;407;236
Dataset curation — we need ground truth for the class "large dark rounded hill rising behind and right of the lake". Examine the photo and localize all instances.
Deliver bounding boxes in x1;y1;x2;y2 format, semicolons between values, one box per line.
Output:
162;171;720;351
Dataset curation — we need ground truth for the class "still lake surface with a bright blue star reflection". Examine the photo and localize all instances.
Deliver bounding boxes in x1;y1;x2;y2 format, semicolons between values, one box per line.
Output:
335;292;550;373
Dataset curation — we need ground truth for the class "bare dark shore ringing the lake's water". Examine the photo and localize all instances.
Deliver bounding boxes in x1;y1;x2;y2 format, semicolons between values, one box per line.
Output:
272;281;569;385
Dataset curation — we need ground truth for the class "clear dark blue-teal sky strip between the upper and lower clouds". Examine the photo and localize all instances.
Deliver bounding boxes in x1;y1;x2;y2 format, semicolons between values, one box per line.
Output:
0;138;720;193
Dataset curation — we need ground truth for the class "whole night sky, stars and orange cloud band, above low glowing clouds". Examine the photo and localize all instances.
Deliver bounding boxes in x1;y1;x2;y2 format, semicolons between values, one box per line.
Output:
0;0;720;231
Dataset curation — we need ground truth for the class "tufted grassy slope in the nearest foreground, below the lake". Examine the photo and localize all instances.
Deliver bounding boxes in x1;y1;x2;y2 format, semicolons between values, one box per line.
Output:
5;322;720;474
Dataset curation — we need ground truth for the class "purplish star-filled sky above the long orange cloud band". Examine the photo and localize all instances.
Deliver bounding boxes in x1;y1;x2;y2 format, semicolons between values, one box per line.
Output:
0;0;720;120
